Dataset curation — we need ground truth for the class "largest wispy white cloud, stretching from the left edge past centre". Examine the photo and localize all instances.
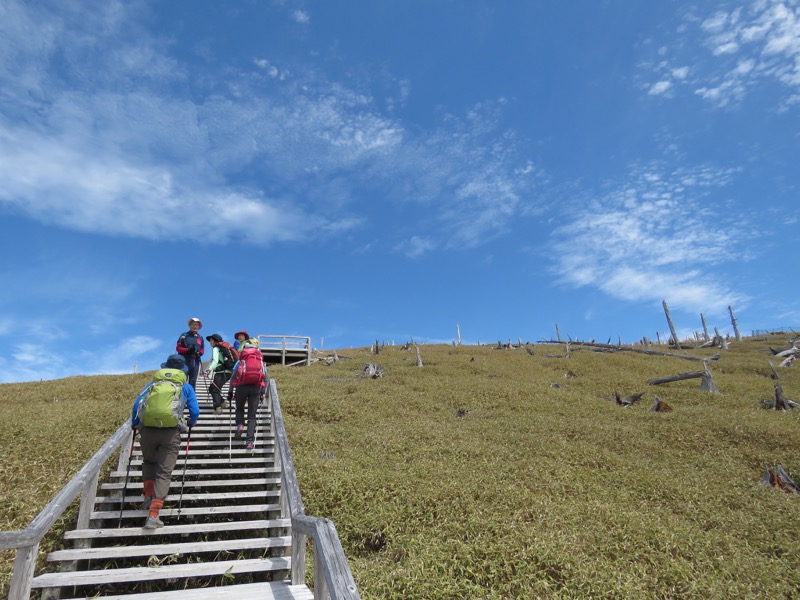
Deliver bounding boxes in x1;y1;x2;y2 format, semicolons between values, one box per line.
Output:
0;0;538;253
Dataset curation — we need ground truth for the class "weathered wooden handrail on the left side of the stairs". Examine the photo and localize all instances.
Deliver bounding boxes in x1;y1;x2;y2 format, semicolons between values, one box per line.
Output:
0;421;131;600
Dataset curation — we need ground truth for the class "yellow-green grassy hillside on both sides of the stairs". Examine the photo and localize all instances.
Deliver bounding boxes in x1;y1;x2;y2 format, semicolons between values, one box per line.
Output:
0;335;800;599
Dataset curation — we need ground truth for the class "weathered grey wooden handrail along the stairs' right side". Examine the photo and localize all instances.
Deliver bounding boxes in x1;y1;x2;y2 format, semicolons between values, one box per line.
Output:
269;379;361;600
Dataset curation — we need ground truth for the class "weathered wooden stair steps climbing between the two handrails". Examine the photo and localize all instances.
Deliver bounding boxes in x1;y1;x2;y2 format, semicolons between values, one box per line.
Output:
32;382;314;600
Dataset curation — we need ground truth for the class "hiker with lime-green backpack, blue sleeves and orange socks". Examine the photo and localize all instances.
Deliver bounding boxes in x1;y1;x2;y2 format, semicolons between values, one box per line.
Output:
131;354;200;529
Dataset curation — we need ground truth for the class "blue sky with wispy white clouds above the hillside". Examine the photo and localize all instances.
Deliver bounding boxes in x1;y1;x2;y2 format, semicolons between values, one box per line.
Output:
0;0;800;382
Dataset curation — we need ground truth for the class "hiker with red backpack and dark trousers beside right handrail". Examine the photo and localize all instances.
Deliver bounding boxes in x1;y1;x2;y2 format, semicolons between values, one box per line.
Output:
228;340;267;450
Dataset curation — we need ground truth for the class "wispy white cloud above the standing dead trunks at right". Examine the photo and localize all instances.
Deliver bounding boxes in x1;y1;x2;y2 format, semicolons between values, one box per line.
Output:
553;163;744;311
